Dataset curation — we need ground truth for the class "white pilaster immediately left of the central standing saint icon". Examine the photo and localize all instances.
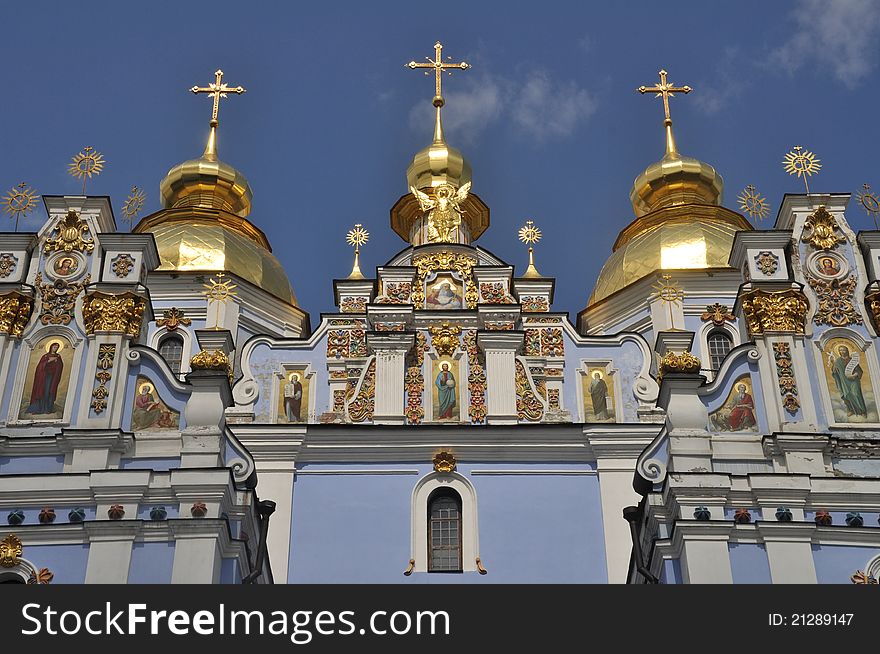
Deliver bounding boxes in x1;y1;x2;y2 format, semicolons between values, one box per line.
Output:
367;332;415;425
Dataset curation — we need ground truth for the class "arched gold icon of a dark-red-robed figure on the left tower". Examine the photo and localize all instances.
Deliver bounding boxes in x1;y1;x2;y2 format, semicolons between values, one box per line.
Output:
19;337;73;420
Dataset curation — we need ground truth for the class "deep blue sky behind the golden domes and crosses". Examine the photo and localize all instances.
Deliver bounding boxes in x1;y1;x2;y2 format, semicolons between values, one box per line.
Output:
0;0;880;324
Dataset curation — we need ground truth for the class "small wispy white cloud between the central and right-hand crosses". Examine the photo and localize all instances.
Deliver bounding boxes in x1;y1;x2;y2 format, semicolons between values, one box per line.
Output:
511;72;596;141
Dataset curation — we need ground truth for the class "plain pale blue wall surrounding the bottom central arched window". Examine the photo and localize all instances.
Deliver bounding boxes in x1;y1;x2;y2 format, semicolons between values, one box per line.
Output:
288;463;607;583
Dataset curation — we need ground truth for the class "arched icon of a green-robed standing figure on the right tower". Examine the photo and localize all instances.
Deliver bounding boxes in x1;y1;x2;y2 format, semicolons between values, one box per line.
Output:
825;338;878;422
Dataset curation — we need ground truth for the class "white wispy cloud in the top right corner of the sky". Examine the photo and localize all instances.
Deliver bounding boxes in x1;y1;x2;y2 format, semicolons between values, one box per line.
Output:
769;0;880;88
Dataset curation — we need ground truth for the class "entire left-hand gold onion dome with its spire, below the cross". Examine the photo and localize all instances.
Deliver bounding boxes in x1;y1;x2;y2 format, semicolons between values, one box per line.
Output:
132;125;297;305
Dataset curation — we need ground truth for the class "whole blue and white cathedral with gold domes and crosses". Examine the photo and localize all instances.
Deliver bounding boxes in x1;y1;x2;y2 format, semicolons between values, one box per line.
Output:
0;53;880;584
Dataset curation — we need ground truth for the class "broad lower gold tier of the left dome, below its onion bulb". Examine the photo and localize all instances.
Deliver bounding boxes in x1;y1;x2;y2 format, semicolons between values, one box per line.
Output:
132;207;296;305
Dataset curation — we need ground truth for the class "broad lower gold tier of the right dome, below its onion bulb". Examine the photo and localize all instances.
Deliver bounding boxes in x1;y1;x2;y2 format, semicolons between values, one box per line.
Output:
588;204;752;306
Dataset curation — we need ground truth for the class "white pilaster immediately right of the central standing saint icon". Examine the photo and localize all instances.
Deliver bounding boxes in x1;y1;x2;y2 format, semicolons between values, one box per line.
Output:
477;331;524;425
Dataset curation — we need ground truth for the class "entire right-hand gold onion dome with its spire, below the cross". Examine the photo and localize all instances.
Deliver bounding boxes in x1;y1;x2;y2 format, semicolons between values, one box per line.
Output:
588;98;752;306
